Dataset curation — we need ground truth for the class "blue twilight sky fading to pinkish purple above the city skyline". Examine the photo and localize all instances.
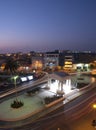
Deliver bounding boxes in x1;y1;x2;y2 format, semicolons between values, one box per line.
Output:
0;0;96;53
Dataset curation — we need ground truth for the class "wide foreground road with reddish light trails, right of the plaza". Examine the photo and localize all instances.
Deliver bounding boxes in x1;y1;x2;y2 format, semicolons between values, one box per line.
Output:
14;82;96;130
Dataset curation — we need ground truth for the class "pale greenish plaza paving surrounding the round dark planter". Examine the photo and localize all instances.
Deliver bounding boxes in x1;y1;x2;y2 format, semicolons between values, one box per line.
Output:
0;90;54;121
